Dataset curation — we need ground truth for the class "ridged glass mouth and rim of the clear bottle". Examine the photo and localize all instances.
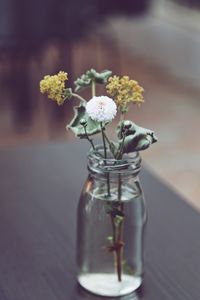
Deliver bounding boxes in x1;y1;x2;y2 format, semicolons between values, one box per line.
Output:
87;145;142;175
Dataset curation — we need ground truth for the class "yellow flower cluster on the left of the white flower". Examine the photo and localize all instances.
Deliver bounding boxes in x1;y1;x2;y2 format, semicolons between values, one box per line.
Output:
40;71;68;105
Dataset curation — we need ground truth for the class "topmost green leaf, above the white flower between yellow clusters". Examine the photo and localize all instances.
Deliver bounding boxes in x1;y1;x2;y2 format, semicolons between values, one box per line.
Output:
74;69;112;92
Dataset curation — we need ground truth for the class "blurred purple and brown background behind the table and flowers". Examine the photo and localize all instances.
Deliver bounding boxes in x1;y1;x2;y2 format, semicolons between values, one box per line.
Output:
0;0;200;209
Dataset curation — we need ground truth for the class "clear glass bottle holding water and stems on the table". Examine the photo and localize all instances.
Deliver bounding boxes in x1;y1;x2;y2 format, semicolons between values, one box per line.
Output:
77;146;146;297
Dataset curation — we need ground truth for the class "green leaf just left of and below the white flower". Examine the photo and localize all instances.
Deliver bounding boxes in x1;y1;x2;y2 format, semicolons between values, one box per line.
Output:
67;103;101;138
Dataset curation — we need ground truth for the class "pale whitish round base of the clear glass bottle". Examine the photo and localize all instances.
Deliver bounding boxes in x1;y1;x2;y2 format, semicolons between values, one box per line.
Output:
78;273;142;297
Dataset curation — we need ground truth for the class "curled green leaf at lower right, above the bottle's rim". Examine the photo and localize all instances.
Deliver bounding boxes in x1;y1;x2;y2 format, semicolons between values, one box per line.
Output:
117;121;157;153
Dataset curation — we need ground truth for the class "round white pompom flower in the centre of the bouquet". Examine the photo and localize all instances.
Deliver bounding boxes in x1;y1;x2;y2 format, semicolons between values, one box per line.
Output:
86;96;117;122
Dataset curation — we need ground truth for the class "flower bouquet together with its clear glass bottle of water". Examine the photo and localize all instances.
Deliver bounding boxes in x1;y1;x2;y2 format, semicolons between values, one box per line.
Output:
40;69;157;296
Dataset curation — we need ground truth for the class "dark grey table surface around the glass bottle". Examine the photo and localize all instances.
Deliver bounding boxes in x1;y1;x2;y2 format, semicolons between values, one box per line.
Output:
0;142;200;300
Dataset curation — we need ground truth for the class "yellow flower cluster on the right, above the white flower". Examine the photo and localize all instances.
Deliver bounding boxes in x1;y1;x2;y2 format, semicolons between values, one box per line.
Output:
106;76;144;113
